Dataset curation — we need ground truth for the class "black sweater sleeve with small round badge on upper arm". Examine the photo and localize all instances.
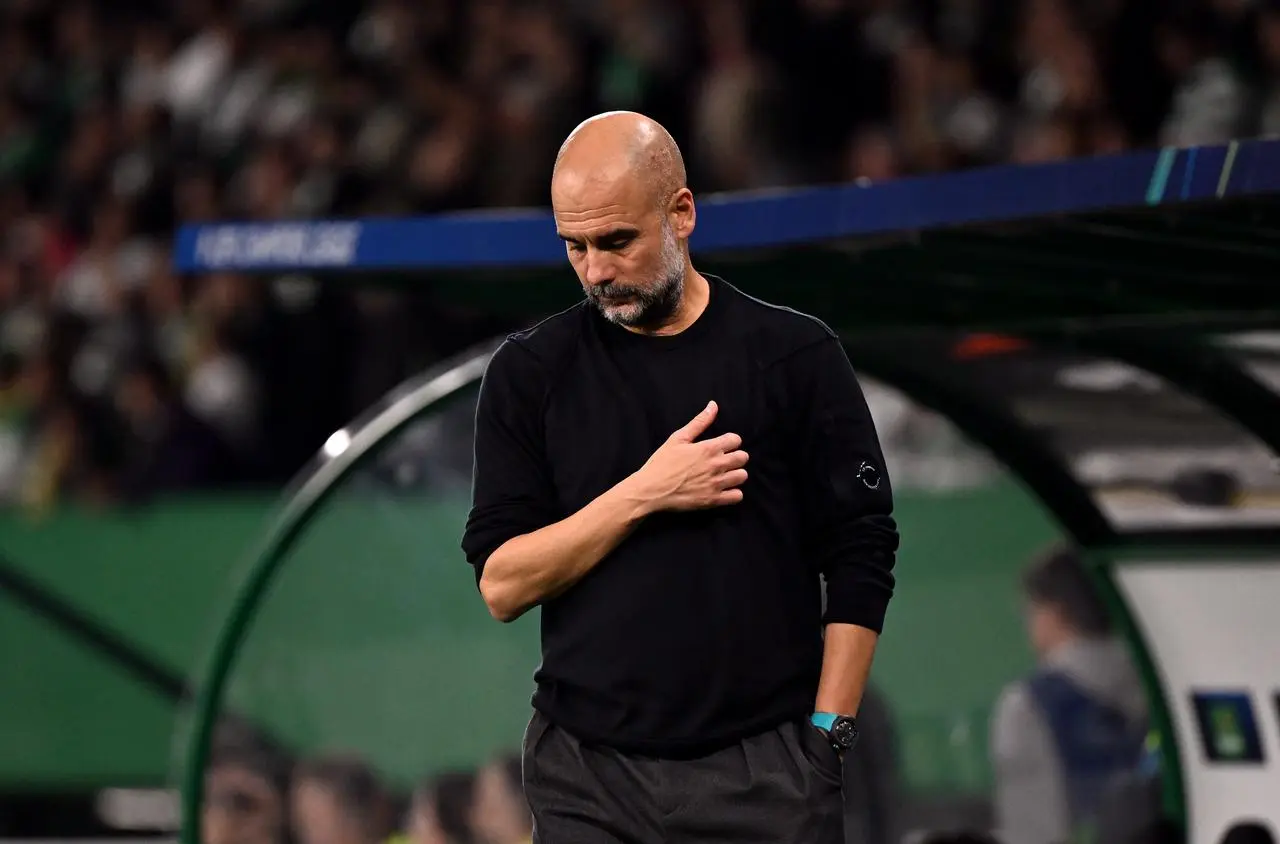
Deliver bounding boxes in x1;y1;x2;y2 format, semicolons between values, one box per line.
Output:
788;336;899;633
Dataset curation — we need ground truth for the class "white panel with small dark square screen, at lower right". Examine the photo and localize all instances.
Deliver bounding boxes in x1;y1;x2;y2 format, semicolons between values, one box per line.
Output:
1116;561;1280;844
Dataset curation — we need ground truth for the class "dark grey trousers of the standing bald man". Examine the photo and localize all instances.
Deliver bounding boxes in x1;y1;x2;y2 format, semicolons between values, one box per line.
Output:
524;713;844;844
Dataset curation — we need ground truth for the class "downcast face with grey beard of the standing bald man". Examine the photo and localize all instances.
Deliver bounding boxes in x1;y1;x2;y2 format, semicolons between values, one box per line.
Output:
552;170;692;329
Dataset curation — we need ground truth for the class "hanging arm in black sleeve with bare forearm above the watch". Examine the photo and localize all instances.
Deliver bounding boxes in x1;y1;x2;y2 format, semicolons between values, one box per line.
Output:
792;337;899;716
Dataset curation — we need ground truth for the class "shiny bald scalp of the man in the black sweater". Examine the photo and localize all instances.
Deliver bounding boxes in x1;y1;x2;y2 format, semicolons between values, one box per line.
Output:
552;111;686;207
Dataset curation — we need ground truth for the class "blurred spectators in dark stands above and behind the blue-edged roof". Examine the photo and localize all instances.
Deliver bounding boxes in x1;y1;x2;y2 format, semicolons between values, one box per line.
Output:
0;0;1280;508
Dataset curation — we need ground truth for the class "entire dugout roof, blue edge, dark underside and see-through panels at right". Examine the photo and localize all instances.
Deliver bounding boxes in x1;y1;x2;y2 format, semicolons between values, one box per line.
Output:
175;141;1280;544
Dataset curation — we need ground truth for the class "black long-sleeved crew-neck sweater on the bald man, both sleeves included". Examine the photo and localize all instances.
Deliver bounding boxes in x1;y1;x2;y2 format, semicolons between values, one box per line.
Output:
462;278;897;756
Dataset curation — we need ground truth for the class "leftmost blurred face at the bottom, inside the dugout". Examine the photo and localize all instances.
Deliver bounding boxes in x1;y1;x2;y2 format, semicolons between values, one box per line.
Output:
201;767;284;844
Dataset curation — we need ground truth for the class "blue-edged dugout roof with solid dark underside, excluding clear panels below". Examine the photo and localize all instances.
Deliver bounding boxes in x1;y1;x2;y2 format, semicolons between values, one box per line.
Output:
175;141;1280;329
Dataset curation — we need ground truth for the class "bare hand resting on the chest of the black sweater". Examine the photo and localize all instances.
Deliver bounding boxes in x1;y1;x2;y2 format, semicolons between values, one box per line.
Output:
632;402;748;511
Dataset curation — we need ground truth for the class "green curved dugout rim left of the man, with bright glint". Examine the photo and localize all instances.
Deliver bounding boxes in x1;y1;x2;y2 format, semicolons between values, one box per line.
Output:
182;342;497;844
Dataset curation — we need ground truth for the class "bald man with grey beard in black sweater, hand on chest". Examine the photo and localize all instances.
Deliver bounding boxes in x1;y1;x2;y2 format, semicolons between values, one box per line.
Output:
462;113;897;844
